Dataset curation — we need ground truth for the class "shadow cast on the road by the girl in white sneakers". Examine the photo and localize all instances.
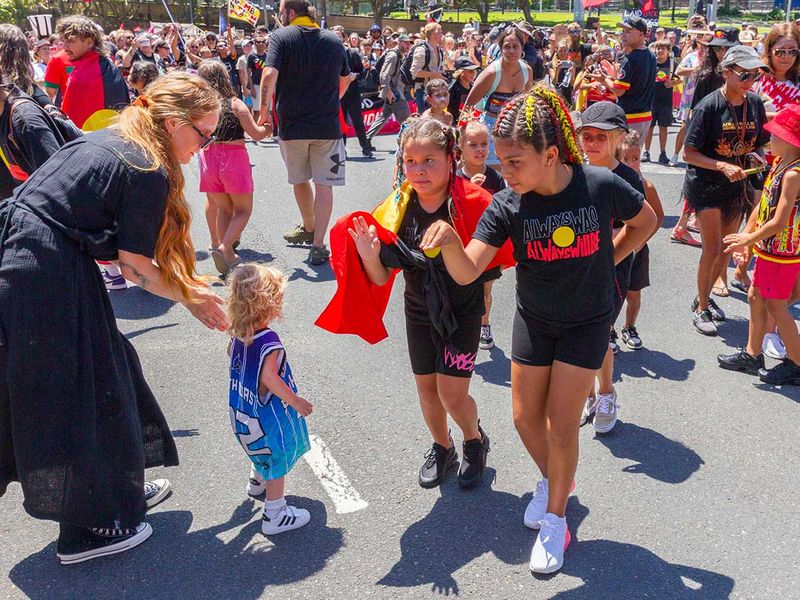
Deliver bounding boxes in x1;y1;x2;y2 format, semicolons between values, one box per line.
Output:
552;496;734;600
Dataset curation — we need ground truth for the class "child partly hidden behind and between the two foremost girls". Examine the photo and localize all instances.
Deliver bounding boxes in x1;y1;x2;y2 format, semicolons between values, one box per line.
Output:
456;121;506;350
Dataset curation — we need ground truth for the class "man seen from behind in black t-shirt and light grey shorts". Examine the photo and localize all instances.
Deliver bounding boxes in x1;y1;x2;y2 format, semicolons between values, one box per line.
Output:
259;0;351;265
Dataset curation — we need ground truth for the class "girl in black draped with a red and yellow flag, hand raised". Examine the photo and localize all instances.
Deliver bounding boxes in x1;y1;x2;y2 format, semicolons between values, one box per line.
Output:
317;118;512;488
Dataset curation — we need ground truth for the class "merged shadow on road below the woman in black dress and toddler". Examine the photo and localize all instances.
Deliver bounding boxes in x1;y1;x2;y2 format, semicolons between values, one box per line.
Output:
10;498;343;600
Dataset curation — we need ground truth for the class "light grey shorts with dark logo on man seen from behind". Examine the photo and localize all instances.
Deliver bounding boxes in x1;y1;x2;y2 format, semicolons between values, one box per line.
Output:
278;138;347;186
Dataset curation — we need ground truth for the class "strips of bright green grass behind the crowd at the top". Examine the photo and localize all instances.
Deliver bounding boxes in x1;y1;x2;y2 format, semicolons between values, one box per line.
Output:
389;8;769;31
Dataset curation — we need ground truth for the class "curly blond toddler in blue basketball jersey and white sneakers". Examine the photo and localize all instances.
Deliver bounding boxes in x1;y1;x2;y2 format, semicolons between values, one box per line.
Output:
228;264;313;535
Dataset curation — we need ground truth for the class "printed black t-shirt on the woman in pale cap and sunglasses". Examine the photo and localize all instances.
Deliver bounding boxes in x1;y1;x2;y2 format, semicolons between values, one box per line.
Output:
684;90;770;204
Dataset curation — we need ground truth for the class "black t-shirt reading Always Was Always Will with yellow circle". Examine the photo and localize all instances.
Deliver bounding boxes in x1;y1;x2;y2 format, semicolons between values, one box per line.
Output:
473;166;644;326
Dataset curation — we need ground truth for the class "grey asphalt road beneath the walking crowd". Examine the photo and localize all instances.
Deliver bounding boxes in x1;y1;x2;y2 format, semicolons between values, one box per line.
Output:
0;129;800;599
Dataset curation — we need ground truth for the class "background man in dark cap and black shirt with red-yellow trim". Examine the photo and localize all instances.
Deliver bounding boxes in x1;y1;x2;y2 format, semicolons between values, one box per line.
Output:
603;16;656;146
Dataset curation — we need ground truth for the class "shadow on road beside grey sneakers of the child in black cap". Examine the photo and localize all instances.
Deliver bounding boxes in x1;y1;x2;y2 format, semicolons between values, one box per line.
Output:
595;421;705;483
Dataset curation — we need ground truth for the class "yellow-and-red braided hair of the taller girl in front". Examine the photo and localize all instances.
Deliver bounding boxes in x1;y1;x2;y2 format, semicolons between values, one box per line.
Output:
492;85;583;165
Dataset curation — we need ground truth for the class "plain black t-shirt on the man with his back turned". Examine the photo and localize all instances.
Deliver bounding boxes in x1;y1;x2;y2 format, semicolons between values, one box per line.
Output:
267;25;350;140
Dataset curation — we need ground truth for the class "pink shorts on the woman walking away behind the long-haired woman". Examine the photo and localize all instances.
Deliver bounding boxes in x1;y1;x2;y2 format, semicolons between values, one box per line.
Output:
198;144;253;194
